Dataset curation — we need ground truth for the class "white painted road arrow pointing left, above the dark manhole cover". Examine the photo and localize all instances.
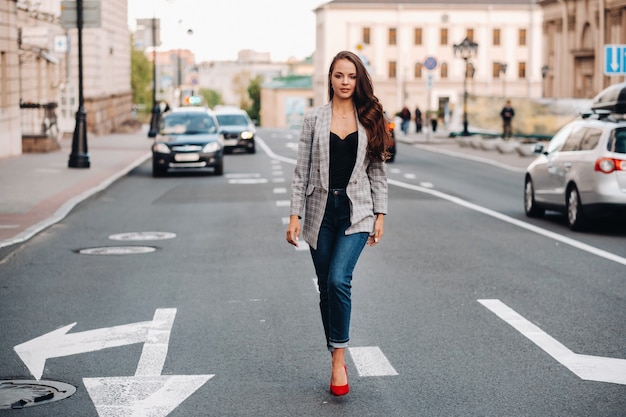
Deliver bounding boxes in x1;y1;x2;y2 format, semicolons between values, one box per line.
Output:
14;321;152;379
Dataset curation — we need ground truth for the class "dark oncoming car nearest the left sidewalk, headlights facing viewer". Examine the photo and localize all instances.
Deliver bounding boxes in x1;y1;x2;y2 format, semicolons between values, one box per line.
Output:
152;107;224;177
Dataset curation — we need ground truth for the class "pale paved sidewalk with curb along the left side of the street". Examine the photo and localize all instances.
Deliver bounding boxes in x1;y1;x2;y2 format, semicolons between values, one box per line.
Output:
0;126;151;250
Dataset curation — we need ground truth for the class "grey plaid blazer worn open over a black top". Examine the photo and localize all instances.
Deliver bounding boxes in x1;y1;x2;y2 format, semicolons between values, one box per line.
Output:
290;103;387;249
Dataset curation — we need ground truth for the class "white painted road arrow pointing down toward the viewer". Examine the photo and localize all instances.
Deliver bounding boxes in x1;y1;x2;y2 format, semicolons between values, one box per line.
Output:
83;309;214;417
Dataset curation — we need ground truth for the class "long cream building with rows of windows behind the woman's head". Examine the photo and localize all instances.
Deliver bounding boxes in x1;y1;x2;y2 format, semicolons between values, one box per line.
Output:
313;0;542;124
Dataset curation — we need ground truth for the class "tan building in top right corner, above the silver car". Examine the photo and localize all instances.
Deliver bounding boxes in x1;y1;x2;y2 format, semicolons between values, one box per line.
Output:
538;0;626;98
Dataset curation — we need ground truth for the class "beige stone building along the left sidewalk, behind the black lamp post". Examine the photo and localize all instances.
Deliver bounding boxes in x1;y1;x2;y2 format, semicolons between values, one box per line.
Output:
0;0;132;157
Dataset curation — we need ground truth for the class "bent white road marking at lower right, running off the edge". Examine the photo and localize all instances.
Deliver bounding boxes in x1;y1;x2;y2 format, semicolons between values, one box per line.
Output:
478;300;626;384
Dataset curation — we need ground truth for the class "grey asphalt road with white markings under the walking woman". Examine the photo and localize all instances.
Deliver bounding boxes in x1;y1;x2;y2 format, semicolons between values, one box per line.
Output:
0;130;626;417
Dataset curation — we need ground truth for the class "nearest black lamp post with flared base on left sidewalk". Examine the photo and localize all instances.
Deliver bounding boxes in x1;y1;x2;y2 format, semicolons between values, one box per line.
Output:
67;0;90;168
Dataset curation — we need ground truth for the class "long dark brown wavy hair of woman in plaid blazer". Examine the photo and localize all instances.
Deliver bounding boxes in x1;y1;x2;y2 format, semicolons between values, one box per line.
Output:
328;51;391;161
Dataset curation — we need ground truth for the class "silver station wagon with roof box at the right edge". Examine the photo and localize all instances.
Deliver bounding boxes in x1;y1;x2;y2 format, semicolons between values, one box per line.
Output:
524;87;626;230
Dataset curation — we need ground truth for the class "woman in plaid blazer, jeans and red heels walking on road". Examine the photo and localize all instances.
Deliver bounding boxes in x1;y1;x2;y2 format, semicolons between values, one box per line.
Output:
287;51;390;395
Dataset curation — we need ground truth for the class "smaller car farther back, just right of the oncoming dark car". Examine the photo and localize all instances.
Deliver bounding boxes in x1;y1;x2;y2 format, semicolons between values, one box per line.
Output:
215;108;256;153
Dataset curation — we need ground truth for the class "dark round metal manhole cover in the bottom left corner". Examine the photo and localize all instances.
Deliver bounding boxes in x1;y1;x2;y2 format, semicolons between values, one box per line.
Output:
0;380;76;410
